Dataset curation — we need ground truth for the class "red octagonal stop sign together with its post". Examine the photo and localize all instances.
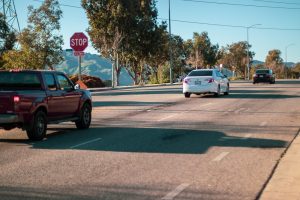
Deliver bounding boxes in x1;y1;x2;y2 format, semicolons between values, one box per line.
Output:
70;32;88;80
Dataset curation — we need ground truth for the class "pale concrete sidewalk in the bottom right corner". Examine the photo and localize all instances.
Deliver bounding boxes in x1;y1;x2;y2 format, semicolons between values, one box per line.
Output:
259;132;300;200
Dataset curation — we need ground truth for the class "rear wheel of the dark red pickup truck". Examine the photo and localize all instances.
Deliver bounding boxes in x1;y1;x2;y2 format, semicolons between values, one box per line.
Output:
26;110;47;140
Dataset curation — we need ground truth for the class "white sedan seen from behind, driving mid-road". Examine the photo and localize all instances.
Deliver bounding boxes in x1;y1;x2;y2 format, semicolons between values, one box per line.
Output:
183;69;229;98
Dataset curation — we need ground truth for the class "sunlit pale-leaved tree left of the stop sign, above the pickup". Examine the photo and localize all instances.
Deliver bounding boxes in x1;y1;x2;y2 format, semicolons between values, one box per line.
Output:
4;0;63;69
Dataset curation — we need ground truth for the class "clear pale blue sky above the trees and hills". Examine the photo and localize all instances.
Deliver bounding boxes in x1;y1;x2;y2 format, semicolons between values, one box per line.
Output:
15;0;300;62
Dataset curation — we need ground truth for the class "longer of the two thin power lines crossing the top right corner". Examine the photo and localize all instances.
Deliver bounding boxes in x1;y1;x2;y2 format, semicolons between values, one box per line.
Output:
181;0;300;10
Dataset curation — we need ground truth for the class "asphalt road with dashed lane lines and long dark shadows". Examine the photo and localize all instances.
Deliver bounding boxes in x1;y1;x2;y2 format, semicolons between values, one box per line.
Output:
0;80;300;200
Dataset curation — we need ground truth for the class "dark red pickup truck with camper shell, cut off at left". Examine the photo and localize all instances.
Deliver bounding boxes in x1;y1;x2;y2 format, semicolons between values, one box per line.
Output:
0;70;92;140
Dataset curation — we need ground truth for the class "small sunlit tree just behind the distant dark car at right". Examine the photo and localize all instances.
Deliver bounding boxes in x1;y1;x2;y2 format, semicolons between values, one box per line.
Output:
265;49;285;78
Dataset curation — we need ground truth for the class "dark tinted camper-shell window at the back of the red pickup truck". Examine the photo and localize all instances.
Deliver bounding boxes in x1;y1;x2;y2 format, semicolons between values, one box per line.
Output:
0;72;41;90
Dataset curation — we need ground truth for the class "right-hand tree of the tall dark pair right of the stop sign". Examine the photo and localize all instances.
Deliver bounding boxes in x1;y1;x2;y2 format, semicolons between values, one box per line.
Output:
123;0;164;84
